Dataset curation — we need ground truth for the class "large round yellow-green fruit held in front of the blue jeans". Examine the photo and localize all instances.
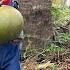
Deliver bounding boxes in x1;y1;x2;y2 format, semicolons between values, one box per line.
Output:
0;5;23;43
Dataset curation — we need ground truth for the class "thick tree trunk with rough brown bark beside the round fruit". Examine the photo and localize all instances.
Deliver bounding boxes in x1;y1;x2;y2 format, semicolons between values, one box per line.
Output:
19;0;52;48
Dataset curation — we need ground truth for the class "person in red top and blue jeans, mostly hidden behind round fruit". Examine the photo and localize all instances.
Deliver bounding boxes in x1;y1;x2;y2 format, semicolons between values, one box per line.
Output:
0;0;21;70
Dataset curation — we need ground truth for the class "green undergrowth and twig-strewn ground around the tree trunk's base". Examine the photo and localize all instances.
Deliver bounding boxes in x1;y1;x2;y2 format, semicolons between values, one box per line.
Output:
21;0;70;70
